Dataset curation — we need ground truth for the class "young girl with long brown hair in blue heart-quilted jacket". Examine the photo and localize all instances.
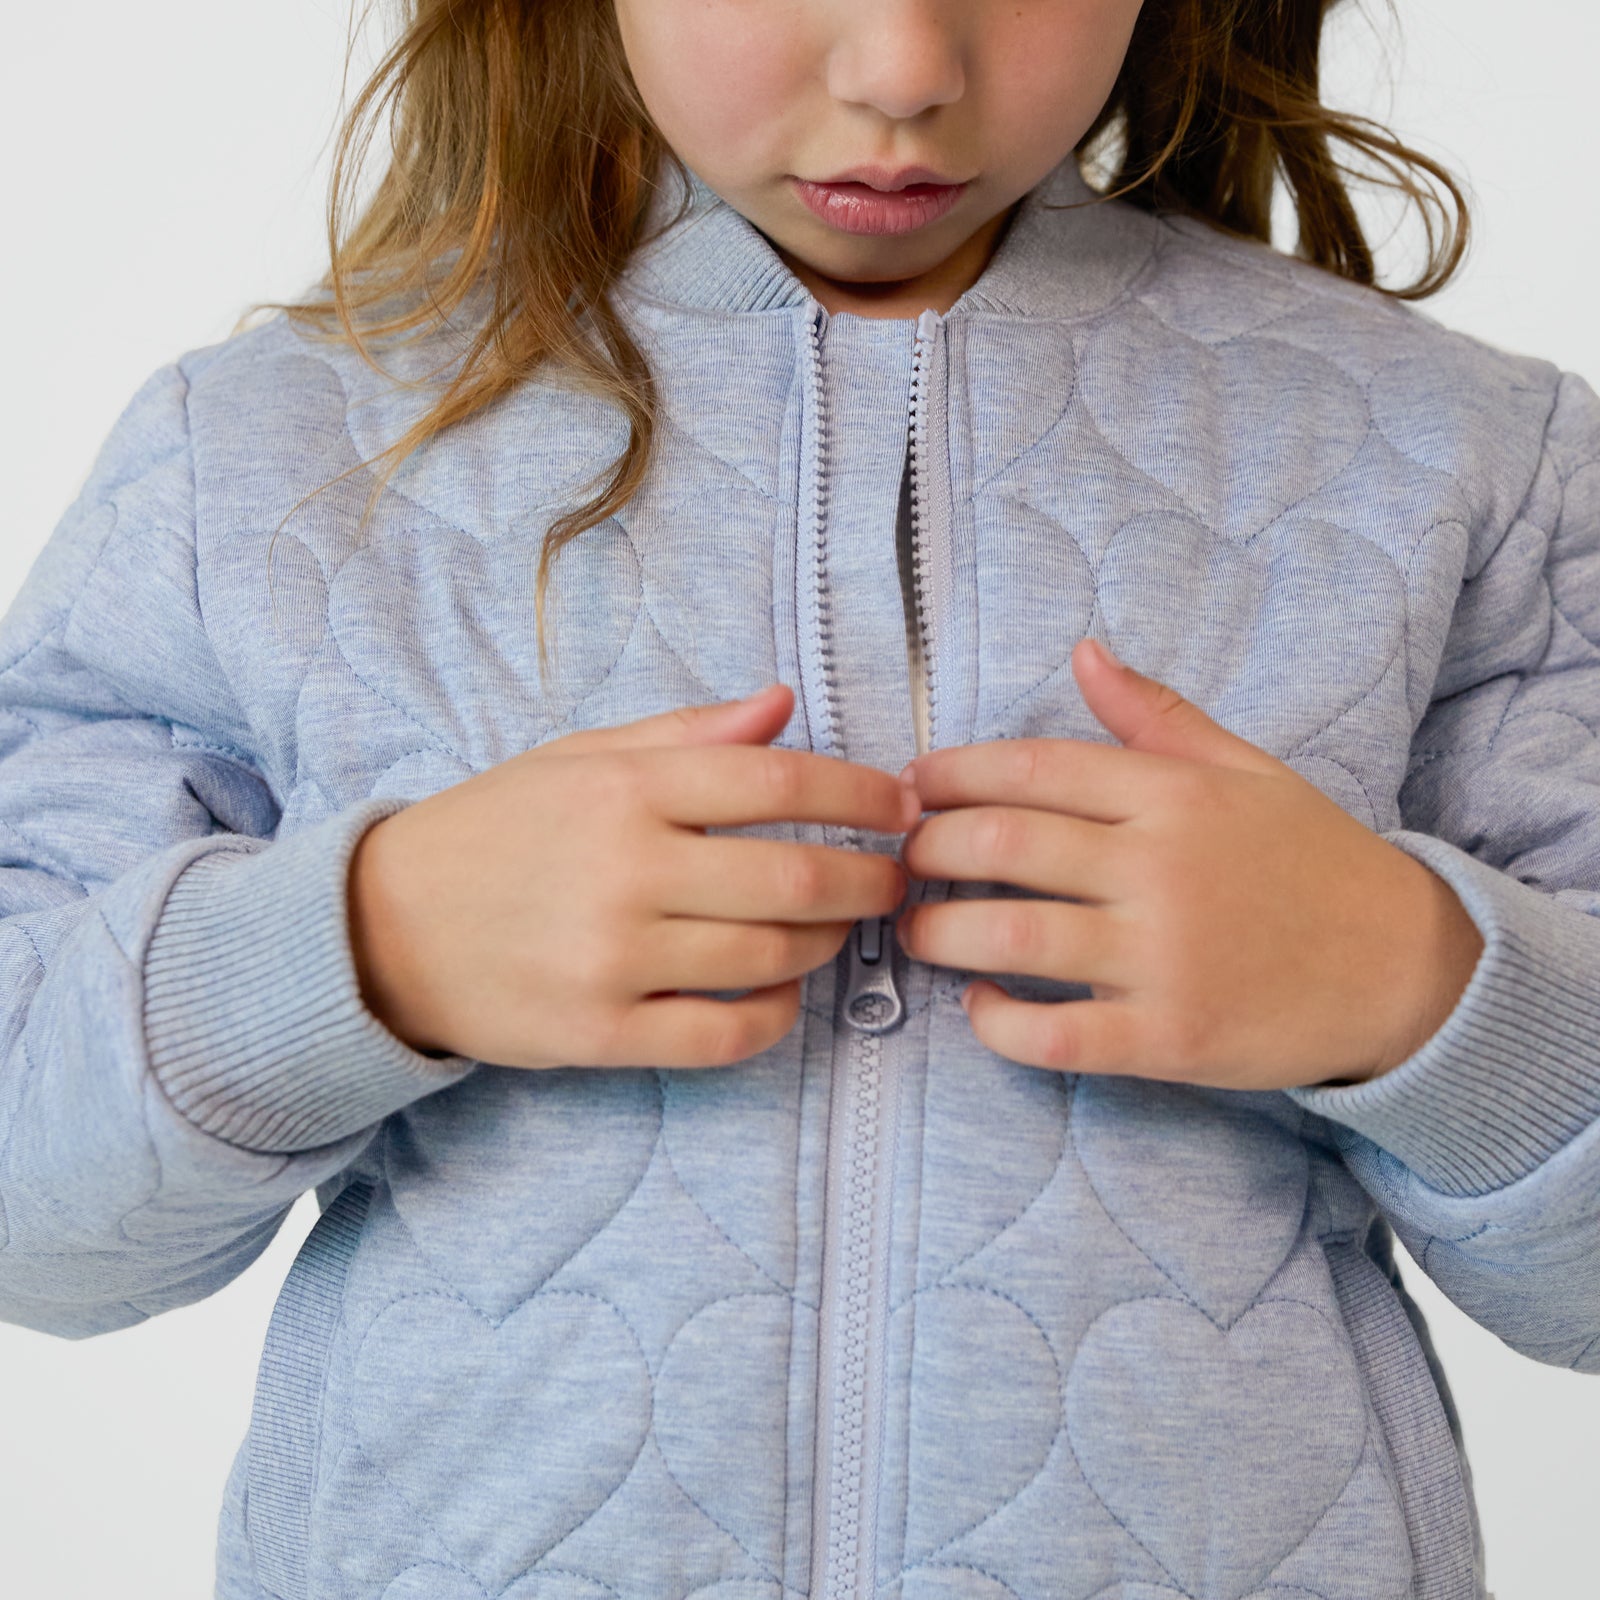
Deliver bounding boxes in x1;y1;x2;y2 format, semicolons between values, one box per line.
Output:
0;0;1600;1600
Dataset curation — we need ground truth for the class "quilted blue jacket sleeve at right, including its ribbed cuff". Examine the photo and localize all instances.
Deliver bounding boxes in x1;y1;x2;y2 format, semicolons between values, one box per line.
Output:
1288;374;1600;1371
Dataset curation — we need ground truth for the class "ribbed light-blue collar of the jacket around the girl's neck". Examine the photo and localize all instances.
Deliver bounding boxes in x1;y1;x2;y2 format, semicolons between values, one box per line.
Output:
621;155;1157;317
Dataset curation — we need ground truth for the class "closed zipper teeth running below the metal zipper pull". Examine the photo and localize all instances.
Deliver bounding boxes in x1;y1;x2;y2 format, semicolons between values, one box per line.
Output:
824;1034;883;1600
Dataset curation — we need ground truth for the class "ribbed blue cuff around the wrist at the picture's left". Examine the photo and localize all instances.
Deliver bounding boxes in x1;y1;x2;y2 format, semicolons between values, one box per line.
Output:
144;798;477;1152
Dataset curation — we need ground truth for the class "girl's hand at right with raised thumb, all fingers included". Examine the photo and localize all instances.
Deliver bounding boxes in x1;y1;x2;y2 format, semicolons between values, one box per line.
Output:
898;642;1483;1090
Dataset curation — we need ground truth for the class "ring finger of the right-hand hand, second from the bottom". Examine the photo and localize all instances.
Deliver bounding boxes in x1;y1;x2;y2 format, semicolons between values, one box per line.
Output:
894;899;1131;989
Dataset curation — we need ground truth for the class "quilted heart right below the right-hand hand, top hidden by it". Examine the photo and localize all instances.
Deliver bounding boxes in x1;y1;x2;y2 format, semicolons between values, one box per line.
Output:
1072;1077;1310;1328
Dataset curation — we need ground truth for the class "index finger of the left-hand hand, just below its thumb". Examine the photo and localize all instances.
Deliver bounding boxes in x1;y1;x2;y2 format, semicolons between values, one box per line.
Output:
627;744;922;834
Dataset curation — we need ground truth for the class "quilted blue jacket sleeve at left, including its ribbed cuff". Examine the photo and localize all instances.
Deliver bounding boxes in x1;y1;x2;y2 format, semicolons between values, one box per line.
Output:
0;360;477;1338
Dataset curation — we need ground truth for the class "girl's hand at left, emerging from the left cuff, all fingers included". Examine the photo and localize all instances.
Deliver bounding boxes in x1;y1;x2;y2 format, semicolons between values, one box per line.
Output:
349;683;922;1067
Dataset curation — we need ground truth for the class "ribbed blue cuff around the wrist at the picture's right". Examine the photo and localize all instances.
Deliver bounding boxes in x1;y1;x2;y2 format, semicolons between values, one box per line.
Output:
1286;829;1600;1195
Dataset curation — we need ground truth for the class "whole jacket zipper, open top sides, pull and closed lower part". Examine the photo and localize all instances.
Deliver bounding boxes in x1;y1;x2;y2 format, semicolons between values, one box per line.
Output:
808;304;939;1600
